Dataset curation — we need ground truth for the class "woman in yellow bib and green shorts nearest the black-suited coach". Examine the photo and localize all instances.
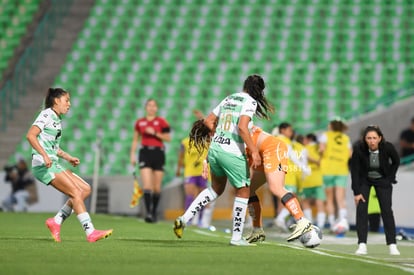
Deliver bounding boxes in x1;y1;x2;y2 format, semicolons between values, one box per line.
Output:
319;118;352;232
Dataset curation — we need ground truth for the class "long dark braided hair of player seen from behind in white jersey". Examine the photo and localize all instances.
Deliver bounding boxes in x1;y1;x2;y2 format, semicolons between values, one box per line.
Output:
243;74;274;119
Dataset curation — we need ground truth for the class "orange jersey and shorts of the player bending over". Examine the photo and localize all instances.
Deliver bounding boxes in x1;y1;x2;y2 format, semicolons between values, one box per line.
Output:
247;127;289;173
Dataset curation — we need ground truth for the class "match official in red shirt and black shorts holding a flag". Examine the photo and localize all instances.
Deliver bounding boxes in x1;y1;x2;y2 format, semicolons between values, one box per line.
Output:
130;99;171;223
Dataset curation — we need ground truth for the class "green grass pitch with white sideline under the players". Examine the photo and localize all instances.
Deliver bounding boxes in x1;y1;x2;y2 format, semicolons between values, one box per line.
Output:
0;213;414;275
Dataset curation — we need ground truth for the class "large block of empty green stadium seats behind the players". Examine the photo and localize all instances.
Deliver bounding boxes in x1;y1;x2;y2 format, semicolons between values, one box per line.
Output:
12;0;414;181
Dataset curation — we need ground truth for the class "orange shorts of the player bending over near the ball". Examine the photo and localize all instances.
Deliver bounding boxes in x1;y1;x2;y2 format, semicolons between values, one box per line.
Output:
249;136;289;173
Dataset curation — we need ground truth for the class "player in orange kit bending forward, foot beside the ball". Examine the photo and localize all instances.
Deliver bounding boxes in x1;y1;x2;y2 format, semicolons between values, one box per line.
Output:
247;126;312;243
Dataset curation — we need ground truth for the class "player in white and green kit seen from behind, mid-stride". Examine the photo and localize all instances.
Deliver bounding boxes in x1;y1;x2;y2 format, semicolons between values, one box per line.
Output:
174;75;273;246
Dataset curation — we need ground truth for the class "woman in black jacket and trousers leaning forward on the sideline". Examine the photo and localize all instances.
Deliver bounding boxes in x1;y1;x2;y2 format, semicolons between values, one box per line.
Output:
350;126;400;255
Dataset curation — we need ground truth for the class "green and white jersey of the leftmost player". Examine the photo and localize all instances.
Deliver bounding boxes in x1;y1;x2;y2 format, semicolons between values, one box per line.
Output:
32;108;62;167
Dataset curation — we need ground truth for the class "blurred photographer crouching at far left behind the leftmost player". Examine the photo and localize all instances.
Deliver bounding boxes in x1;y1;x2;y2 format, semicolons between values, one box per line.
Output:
2;159;38;212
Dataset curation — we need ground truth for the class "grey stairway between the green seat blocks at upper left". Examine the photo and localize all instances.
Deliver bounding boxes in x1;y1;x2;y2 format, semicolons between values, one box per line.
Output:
0;0;94;168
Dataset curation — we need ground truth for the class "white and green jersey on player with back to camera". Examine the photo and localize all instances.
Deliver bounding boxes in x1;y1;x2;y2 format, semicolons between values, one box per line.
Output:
210;92;257;156
